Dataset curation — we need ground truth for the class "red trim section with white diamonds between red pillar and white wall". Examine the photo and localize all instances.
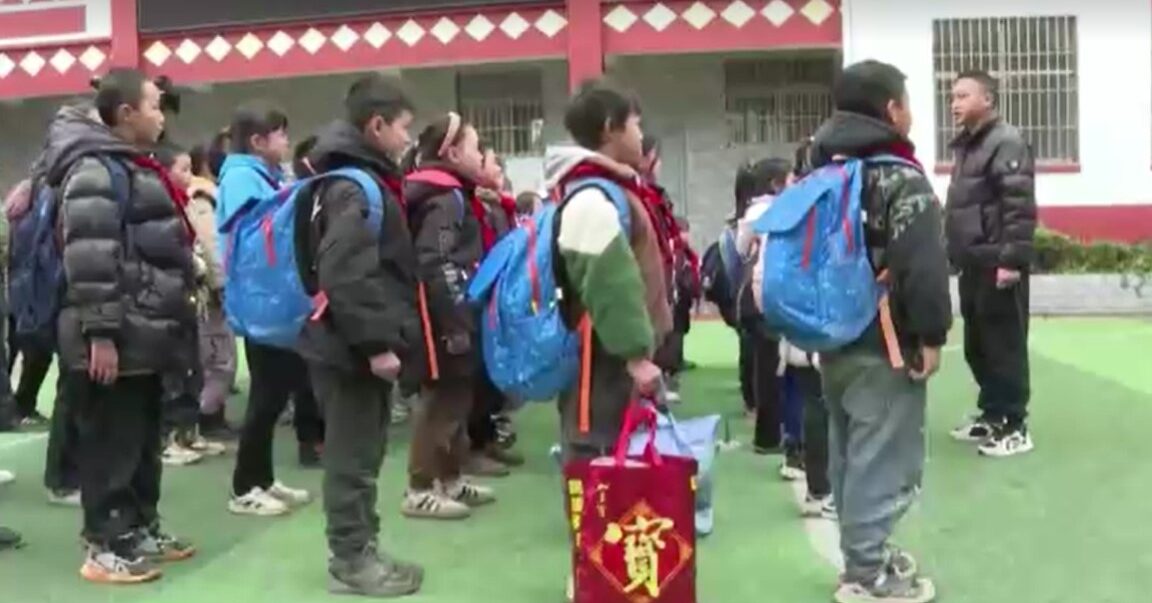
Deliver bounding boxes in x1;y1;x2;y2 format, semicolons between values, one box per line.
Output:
602;0;843;54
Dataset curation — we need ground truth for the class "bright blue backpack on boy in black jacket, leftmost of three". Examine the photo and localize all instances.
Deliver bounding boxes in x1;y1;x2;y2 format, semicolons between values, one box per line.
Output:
220;168;384;349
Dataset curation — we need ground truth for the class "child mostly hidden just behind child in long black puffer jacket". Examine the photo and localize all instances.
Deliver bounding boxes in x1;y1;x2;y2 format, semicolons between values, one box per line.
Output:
156;141;226;467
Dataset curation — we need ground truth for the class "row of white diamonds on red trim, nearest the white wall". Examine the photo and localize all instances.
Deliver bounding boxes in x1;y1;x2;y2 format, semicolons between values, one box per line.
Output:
604;0;836;33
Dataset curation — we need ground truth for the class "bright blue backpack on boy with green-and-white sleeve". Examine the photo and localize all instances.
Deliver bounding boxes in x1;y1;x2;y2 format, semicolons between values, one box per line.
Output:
468;178;631;401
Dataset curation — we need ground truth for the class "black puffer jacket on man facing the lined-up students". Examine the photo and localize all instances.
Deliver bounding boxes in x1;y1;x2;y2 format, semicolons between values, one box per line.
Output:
945;118;1036;270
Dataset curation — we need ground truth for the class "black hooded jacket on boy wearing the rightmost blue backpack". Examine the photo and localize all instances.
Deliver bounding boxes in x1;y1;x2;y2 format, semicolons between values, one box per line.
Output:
812;113;952;351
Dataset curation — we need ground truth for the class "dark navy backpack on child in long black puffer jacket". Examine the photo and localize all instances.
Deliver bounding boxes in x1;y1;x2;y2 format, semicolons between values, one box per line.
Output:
8;156;131;345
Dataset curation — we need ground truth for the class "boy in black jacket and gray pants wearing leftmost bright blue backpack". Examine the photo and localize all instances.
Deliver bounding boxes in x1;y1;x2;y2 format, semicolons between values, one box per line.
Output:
300;75;424;597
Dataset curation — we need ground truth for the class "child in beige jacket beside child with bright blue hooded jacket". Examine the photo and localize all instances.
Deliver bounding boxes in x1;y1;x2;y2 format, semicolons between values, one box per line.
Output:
188;143;240;442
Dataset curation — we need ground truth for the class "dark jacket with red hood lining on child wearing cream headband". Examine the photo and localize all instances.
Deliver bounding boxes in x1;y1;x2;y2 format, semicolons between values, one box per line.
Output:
404;164;484;378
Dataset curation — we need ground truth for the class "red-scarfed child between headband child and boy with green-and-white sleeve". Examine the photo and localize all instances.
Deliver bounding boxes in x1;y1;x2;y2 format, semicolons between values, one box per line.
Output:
464;146;524;477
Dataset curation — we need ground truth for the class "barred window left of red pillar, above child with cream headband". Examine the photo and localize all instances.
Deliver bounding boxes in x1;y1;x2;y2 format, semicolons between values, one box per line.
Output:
456;69;544;156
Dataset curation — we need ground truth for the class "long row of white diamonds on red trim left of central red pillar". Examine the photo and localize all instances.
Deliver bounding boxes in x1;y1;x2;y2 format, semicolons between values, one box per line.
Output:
143;10;568;67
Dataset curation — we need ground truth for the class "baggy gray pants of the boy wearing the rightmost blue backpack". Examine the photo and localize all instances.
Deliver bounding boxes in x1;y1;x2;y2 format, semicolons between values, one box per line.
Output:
823;351;927;581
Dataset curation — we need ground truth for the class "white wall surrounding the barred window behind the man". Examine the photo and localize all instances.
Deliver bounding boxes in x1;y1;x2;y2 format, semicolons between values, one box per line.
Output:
844;0;1152;205
